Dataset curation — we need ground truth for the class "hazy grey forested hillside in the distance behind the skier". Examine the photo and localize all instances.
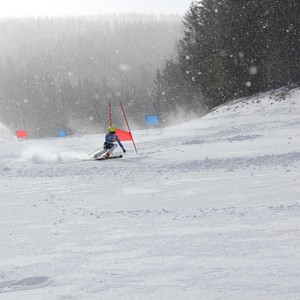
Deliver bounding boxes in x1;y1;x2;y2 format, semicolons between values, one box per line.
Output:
0;14;183;137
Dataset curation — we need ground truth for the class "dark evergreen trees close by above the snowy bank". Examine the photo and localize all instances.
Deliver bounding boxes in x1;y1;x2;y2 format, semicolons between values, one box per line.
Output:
155;0;300;117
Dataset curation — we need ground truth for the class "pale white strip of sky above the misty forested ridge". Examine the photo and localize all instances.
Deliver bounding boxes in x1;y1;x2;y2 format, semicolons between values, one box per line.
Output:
0;0;192;18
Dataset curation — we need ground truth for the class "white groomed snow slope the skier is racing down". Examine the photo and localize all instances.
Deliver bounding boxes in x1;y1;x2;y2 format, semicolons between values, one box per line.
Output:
0;90;300;300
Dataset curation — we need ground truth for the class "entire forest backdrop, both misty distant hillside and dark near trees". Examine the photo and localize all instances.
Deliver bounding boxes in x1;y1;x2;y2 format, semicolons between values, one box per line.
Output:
0;0;300;136
